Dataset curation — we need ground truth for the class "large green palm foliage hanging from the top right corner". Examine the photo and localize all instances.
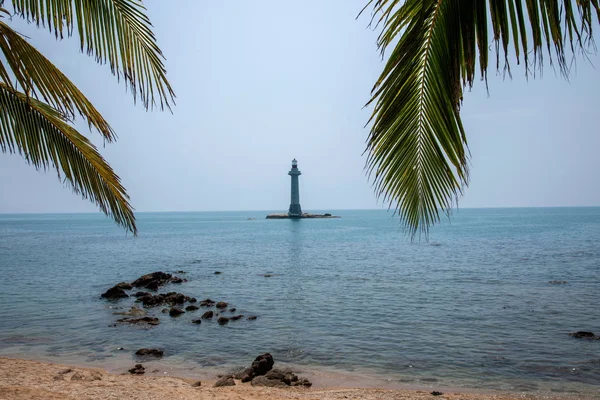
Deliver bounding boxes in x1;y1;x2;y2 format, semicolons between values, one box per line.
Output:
366;0;600;238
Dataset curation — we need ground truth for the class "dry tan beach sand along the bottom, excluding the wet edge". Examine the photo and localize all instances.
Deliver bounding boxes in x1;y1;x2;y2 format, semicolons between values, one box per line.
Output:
0;358;583;400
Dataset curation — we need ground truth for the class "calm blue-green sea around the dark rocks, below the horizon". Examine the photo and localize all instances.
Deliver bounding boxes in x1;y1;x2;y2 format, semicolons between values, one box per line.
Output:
0;207;600;396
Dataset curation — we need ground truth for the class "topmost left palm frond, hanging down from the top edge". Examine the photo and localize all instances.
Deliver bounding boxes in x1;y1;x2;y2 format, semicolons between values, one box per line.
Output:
12;0;175;109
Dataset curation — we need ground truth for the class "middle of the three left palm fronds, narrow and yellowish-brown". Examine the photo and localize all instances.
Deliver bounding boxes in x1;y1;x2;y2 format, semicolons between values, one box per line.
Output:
0;21;115;141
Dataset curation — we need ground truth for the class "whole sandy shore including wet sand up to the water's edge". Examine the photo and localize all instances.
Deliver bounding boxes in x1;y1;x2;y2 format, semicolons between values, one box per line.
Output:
0;356;600;400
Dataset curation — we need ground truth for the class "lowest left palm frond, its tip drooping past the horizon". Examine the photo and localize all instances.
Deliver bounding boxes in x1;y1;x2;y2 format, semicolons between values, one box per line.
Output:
0;83;137;235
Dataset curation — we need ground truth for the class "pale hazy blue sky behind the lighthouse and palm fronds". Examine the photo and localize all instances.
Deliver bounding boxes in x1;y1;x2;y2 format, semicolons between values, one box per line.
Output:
0;0;600;213
